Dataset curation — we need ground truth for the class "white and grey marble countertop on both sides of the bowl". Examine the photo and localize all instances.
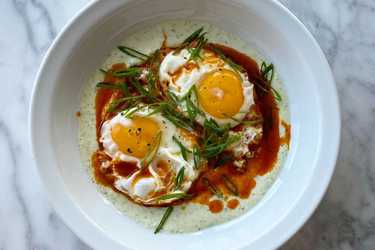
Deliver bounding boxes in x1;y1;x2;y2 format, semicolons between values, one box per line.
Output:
0;0;375;250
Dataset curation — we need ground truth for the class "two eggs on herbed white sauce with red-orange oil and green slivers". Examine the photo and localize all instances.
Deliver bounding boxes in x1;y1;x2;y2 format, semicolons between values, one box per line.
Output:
80;21;290;232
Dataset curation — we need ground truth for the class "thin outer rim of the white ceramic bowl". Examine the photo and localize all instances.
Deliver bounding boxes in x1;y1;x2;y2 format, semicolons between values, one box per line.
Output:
28;0;341;249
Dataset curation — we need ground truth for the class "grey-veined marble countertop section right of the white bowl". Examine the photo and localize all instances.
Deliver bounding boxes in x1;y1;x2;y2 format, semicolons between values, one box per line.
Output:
282;0;375;250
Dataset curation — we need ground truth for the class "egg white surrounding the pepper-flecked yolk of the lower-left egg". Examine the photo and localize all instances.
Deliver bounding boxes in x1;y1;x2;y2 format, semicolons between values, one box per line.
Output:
100;108;199;205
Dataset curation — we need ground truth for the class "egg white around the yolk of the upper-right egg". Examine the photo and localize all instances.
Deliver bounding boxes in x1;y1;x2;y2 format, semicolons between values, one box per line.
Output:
159;49;255;127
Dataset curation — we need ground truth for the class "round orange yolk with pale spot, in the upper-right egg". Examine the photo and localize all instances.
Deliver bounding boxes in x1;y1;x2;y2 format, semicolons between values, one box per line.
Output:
197;69;244;118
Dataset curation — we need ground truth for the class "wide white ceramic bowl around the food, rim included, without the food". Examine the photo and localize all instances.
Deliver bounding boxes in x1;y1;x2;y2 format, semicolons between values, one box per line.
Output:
30;0;340;250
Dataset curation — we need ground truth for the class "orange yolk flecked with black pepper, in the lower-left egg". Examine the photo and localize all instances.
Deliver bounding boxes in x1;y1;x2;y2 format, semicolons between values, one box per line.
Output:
111;116;160;159
